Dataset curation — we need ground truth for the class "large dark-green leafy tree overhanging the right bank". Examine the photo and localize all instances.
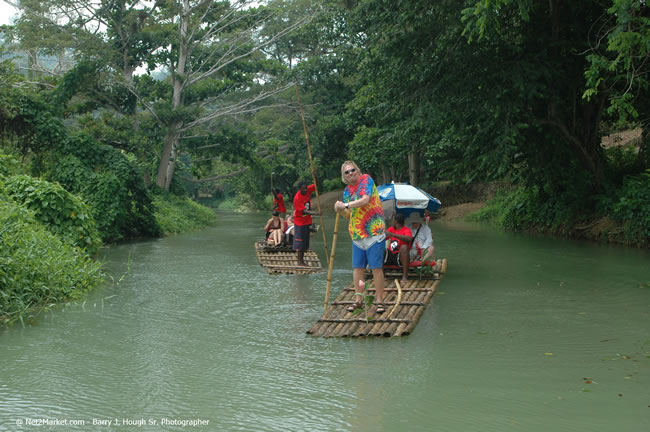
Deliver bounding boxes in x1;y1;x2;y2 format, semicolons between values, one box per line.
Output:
350;0;628;190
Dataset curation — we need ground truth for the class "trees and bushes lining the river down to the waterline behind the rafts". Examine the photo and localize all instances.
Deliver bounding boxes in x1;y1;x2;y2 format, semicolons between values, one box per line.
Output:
0;0;650;322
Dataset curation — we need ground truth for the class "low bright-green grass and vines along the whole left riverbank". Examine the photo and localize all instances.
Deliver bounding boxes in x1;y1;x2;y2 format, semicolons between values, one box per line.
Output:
0;155;215;325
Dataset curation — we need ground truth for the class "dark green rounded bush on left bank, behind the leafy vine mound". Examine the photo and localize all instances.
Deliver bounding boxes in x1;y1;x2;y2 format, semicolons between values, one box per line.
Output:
51;134;160;242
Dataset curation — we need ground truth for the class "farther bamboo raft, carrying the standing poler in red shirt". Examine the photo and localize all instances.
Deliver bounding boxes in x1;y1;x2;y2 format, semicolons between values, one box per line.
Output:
255;241;323;274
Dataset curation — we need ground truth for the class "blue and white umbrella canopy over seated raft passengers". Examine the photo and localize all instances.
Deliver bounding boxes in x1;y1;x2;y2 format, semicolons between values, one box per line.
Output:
377;183;442;216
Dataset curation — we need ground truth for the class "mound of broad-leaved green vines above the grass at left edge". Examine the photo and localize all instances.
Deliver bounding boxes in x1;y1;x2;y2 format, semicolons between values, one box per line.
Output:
0;175;101;255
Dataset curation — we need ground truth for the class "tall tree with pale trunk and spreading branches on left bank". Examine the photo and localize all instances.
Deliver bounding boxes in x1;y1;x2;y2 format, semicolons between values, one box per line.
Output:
6;0;315;190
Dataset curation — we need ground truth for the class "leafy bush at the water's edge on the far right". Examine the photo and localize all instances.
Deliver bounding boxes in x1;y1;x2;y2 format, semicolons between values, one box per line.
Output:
612;170;650;245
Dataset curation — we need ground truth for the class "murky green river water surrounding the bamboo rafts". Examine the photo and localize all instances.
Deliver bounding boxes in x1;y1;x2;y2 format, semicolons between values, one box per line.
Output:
0;212;650;432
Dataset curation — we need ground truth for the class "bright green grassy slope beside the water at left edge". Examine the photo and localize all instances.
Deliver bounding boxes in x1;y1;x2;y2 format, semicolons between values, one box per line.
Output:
0;195;105;325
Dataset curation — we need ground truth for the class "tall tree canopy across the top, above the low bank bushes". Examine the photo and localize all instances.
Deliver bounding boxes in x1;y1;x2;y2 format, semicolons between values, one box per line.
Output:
4;0;650;240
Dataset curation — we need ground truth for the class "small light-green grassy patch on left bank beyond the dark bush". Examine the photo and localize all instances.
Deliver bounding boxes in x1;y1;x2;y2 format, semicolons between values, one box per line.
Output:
153;194;216;234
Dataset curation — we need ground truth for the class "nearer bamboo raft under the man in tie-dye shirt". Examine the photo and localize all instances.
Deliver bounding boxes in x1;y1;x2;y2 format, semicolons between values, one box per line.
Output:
307;259;447;337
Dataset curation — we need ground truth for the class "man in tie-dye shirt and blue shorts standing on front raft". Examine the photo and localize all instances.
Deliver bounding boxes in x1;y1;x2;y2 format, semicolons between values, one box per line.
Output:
334;161;386;314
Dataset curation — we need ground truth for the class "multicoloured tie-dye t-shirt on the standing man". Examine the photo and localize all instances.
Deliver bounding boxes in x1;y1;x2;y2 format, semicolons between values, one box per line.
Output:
343;174;386;240
